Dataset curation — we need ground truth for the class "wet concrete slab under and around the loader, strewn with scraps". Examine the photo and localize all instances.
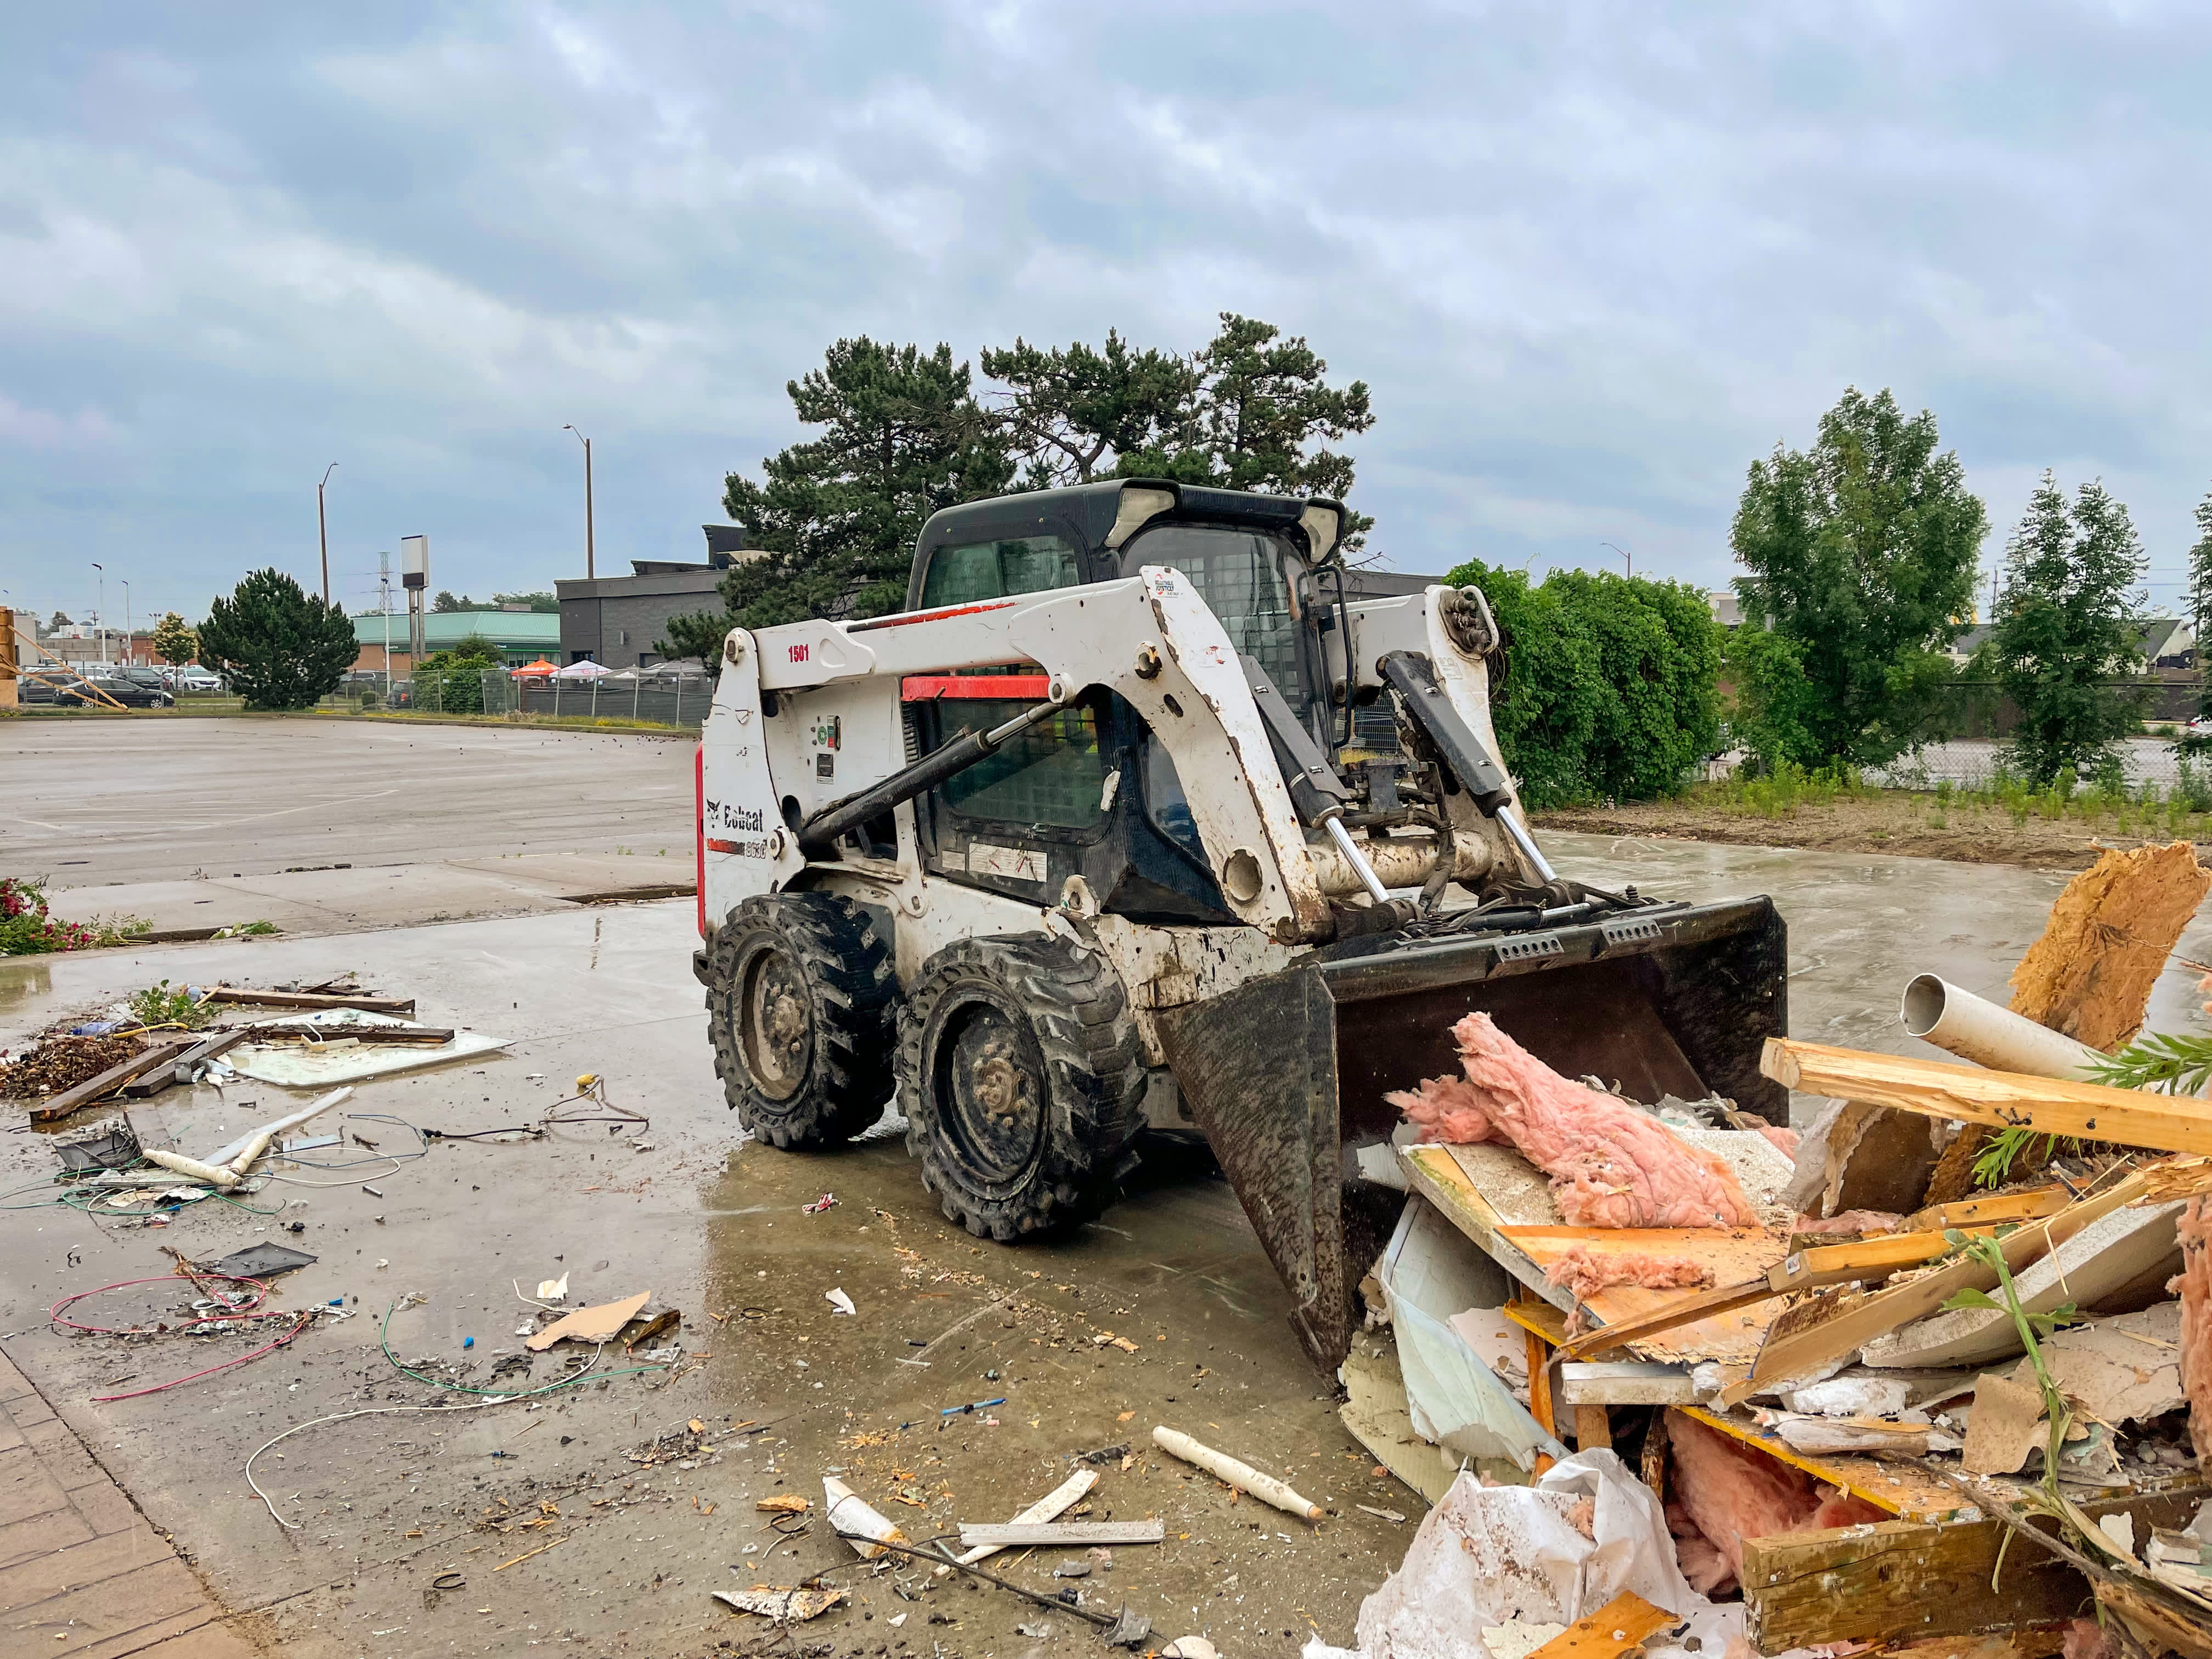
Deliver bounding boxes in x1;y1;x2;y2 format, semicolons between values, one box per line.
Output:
0;836;2203;1659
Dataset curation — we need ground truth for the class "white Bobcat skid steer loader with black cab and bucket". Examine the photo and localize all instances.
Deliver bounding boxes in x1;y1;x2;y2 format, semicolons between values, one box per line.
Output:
695;480;1787;1369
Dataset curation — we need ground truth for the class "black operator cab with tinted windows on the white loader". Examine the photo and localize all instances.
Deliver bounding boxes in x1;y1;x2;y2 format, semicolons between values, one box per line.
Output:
907;478;1350;924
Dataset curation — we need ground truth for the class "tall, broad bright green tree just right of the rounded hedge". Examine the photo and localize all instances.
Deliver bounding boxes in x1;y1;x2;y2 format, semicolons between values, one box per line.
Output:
1730;387;1989;765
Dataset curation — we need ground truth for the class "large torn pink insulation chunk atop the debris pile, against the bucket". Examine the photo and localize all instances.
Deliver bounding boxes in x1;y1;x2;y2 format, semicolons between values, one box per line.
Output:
1387;1013;1758;1228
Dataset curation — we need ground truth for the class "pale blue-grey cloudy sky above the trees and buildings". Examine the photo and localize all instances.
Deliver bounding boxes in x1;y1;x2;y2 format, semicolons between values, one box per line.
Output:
0;0;2212;622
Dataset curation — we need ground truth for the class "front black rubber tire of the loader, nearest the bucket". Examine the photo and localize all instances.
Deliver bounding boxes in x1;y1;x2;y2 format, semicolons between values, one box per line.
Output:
898;934;1146;1243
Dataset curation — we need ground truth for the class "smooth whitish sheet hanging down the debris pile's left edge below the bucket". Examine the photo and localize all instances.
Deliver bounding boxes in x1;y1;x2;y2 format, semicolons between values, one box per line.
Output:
1376;1194;1566;1469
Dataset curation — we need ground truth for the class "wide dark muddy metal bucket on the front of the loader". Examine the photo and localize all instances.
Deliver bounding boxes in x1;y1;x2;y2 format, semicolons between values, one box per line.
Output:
1159;898;1790;1374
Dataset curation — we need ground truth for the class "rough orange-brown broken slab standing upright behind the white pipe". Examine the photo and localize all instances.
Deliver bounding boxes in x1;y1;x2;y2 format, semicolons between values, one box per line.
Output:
2011;840;2212;1053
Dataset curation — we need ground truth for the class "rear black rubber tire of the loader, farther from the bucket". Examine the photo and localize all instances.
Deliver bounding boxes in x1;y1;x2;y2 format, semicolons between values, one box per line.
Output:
706;894;898;1153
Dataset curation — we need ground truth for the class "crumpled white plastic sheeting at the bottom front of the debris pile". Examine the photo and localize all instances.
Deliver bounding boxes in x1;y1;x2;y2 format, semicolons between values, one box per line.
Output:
1358;1449;1743;1659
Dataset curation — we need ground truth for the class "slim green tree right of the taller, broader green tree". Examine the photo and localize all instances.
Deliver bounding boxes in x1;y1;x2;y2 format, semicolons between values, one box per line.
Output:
1991;471;2143;785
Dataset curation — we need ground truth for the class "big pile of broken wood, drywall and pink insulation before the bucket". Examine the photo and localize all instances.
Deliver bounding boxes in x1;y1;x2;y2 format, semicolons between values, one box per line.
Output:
1336;843;2212;1659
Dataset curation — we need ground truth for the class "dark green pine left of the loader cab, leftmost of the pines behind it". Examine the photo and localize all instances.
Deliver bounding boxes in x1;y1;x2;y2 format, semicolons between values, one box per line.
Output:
657;336;1013;666
